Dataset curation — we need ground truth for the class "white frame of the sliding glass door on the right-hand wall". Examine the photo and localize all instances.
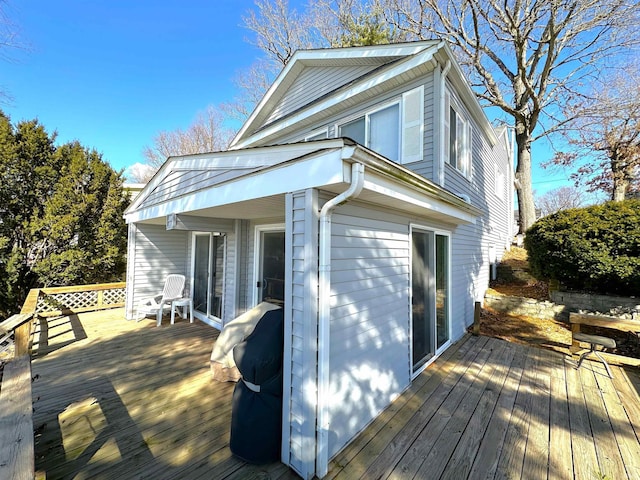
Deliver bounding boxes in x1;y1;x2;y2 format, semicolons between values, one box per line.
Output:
409;223;453;381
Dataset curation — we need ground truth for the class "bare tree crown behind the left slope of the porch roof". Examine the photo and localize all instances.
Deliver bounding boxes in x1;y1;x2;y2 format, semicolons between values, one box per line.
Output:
135;106;233;181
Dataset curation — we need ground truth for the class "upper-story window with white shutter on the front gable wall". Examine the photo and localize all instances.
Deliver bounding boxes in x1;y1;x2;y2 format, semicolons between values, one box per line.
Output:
337;87;424;167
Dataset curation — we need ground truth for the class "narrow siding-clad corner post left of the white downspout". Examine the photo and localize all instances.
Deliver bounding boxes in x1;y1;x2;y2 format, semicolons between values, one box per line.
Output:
282;190;318;478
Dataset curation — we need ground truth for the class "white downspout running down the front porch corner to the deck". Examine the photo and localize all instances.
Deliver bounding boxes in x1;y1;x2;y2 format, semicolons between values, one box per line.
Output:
316;163;364;478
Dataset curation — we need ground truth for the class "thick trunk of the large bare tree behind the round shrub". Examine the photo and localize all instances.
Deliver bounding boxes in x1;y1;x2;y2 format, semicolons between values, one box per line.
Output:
516;126;536;233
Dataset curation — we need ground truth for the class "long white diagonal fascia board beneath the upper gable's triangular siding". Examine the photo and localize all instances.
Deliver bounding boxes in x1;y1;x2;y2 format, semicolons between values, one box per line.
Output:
233;47;437;149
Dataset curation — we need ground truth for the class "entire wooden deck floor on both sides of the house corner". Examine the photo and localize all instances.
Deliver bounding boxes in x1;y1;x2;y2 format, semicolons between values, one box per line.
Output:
33;309;640;480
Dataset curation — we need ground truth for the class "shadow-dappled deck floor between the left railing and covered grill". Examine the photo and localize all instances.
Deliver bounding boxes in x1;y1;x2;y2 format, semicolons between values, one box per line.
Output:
27;309;297;480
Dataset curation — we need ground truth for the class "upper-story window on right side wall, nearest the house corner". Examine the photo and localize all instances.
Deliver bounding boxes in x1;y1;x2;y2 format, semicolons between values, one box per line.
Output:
444;92;472;178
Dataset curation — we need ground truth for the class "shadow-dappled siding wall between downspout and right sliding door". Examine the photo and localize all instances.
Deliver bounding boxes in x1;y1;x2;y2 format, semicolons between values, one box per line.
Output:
329;205;410;456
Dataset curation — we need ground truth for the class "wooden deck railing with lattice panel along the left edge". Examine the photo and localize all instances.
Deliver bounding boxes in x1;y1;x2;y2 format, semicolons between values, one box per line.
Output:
0;282;126;480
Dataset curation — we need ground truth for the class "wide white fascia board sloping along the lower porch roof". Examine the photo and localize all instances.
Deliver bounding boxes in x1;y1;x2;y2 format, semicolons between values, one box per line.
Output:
125;149;348;223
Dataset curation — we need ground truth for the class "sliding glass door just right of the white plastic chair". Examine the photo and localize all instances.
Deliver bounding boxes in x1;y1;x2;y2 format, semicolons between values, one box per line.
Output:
193;233;226;319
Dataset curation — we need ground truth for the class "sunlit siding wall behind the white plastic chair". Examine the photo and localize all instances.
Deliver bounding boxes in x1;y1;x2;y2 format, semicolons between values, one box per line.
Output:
127;224;189;318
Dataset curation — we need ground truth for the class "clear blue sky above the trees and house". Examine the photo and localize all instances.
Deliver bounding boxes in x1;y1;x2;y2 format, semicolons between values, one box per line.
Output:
0;0;567;193
